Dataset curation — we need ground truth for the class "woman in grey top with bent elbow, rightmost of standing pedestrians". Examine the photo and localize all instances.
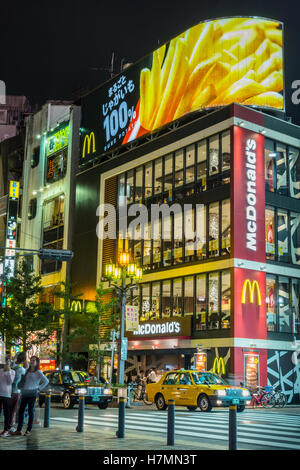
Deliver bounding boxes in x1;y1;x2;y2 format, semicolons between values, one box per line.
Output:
11;356;49;436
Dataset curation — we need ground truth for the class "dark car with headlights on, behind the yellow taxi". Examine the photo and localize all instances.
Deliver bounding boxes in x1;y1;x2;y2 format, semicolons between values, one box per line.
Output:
39;370;113;410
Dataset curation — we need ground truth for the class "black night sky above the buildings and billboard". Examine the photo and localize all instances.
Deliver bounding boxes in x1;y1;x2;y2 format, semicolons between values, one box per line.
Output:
0;0;300;125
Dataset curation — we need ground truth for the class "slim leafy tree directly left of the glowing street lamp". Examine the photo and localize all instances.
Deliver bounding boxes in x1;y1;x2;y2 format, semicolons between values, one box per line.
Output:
68;284;120;379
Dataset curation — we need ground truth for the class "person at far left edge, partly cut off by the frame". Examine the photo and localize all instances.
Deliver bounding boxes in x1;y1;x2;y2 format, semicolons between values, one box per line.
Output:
0;357;15;437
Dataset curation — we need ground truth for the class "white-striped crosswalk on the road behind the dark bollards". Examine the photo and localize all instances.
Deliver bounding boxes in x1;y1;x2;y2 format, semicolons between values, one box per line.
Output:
51;410;300;450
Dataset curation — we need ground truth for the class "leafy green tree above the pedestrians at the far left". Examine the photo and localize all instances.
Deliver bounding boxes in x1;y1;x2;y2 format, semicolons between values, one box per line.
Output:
1;259;58;351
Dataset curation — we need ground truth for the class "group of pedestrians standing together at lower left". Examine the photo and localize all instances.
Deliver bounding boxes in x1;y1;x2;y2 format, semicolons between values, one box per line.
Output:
0;352;49;437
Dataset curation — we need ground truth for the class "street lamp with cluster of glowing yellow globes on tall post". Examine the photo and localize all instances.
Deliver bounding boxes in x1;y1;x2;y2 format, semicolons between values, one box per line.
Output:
105;252;143;384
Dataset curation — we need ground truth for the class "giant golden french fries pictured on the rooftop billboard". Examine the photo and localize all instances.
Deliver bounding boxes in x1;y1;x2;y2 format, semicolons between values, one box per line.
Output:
140;18;283;131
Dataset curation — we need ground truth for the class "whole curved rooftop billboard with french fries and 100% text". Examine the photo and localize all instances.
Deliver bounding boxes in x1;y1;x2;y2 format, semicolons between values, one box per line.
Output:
81;17;284;161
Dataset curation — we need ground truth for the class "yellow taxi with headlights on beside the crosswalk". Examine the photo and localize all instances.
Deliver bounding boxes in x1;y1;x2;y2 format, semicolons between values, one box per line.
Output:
146;370;251;411
